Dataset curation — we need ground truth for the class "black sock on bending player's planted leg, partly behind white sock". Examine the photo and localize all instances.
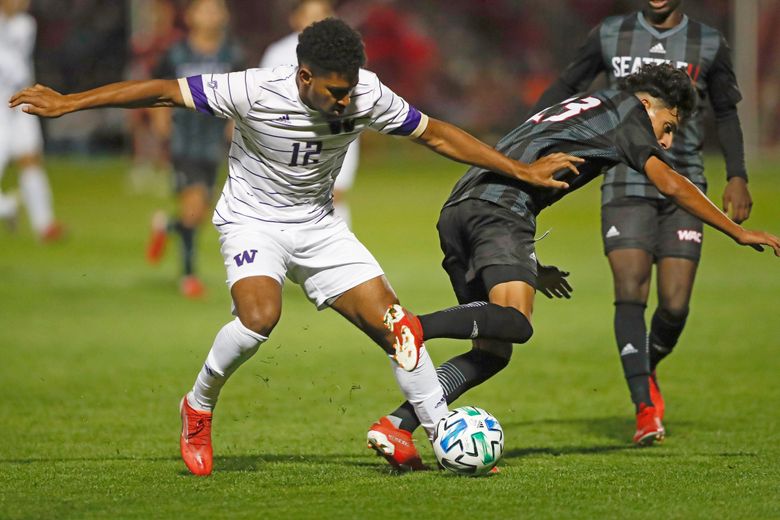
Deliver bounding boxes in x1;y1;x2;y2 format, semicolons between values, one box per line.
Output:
390;349;509;432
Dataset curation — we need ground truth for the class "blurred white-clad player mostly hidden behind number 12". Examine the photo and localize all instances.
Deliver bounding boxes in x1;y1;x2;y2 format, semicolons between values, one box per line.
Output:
260;0;360;226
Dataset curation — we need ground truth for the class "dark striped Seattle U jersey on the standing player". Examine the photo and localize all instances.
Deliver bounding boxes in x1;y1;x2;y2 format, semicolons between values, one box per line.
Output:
537;12;744;204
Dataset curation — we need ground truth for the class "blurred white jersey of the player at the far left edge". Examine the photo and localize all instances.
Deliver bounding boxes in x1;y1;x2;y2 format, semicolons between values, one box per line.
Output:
0;13;36;93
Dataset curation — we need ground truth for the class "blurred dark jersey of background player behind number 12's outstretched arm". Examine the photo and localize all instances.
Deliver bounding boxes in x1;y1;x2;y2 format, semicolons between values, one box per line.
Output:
155;39;243;163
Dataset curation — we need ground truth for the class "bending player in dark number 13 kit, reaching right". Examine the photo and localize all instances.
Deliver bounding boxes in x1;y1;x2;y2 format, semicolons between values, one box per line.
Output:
368;65;780;469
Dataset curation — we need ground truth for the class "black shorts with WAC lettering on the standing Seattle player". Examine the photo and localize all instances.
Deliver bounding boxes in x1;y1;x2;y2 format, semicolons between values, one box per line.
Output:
601;197;704;262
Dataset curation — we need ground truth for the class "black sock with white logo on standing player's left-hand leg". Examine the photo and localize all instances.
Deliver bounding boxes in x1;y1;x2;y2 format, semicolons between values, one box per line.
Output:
615;302;652;407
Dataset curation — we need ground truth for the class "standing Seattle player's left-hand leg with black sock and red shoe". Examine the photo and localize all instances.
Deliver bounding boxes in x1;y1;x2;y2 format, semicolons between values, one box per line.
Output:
607;249;664;445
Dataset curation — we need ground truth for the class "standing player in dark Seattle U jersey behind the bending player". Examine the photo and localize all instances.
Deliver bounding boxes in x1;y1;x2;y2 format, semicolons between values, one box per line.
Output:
532;0;752;442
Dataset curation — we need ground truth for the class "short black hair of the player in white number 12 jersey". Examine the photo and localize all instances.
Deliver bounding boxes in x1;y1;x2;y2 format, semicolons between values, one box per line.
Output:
296;18;366;76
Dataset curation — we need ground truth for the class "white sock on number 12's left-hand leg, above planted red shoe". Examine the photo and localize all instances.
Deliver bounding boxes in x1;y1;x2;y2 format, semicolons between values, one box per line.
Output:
187;318;268;411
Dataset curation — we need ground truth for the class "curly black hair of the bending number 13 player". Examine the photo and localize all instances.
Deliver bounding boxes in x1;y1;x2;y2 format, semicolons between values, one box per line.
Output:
620;63;696;121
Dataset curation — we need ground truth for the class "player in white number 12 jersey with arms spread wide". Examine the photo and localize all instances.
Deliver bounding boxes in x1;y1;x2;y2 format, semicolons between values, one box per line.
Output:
10;18;582;475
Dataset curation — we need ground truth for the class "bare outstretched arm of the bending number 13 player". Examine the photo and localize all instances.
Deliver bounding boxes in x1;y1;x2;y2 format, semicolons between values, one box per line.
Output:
645;156;780;256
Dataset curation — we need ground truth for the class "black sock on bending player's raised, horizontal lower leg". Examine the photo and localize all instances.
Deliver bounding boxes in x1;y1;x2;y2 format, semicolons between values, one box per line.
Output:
418;302;533;343
